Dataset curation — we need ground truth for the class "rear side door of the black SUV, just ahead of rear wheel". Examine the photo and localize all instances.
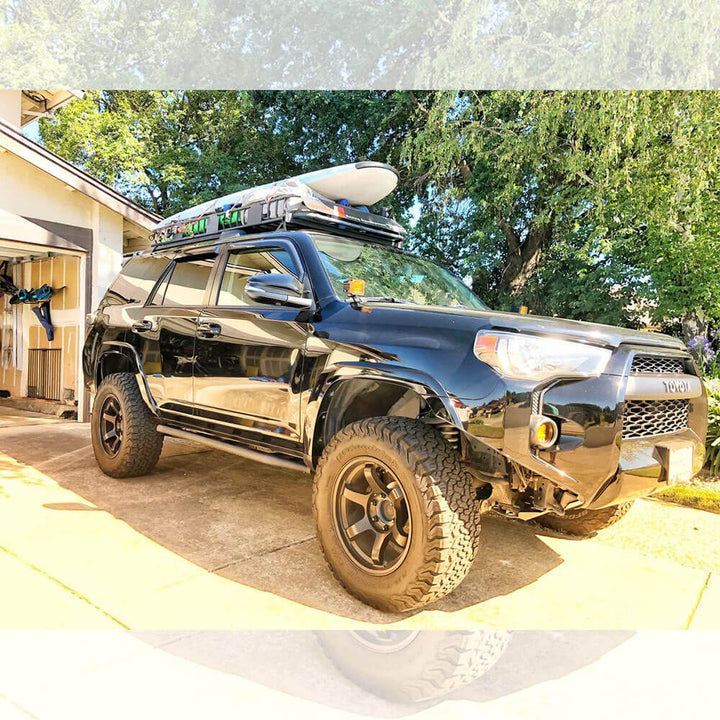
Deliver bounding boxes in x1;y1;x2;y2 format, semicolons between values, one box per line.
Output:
130;255;215;421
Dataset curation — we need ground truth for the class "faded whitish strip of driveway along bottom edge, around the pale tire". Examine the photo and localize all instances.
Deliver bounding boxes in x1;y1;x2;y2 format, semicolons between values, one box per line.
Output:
5;630;718;720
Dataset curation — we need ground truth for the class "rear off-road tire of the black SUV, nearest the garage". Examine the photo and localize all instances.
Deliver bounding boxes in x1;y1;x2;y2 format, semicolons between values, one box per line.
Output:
90;373;164;478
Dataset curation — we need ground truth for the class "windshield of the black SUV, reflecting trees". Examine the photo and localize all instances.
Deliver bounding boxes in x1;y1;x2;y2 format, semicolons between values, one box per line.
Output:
313;235;488;310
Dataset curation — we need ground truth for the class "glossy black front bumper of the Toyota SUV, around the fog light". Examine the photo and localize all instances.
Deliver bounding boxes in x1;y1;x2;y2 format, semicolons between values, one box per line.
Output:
458;346;707;508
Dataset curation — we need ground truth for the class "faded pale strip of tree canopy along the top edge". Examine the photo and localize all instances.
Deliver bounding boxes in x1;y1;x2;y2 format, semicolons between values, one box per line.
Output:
5;0;720;89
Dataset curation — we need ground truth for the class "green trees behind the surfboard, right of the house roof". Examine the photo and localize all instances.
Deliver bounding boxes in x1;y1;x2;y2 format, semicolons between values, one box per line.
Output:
40;90;424;215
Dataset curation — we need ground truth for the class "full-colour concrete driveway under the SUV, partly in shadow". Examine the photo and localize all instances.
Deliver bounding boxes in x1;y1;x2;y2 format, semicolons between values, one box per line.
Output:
0;411;720;629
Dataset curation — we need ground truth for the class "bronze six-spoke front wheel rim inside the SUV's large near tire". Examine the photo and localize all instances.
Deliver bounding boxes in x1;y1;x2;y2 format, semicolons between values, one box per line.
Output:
333;457;412;575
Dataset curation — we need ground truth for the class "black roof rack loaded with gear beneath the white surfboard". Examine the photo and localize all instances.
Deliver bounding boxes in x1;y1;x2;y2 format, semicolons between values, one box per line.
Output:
150;188;405;251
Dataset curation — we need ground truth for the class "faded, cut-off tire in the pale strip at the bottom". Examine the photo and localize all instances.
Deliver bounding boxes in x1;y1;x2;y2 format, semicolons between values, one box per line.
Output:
318;630;511;703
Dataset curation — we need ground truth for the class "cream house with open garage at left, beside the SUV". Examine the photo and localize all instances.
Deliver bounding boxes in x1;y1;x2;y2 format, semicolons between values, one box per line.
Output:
0;90;160;420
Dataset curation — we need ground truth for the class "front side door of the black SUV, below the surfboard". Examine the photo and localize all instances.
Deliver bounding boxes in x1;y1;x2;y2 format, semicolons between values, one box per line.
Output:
195;239;309;450
